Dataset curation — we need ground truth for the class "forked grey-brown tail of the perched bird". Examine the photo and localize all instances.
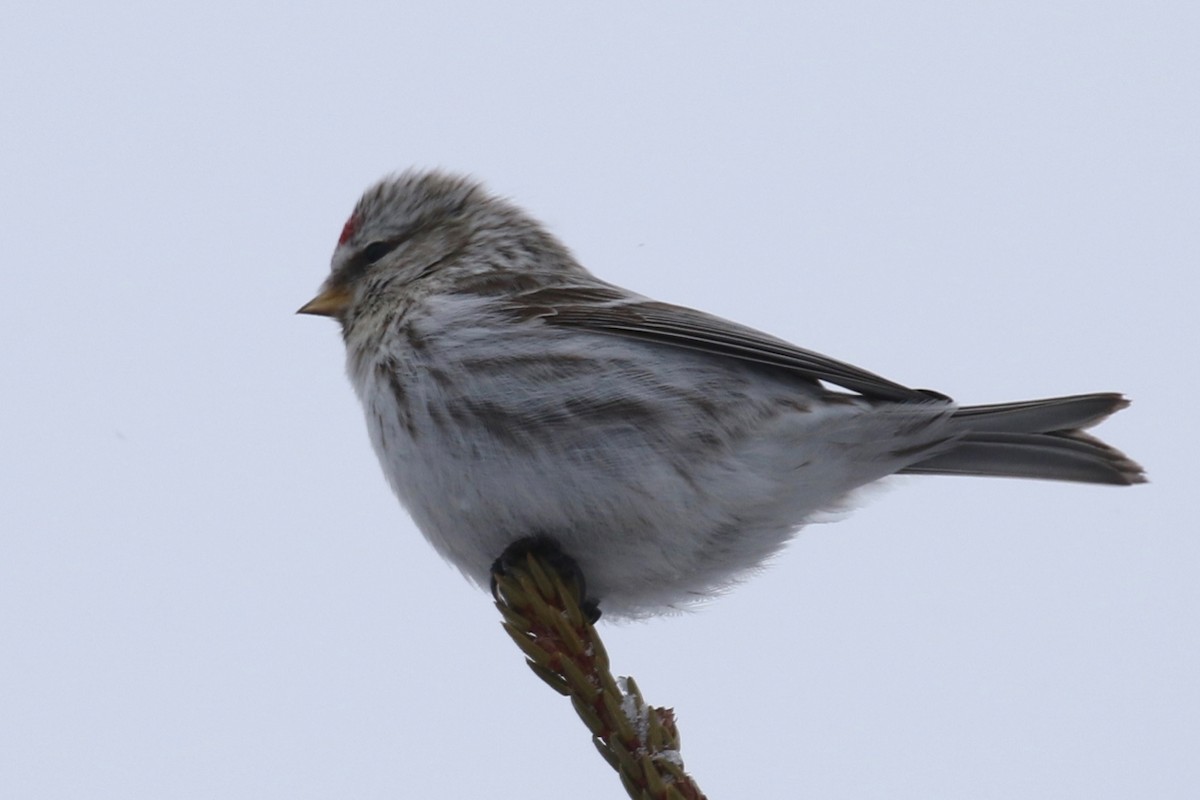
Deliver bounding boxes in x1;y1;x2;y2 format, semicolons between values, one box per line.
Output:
900;393;1146;486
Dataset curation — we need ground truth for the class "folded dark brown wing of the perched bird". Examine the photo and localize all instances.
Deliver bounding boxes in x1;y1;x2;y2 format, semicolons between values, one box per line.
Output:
515;287;926;402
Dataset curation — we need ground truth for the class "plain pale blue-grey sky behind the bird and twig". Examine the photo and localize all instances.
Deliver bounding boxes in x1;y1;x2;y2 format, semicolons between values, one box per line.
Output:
0;0;1200;800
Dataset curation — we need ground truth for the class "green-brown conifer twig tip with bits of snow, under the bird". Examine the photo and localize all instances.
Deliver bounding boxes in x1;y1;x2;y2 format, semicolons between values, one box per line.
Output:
493;553;704;800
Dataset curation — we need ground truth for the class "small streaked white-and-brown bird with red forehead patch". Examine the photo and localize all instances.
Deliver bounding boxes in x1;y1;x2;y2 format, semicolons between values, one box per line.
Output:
300;172;1145;618
